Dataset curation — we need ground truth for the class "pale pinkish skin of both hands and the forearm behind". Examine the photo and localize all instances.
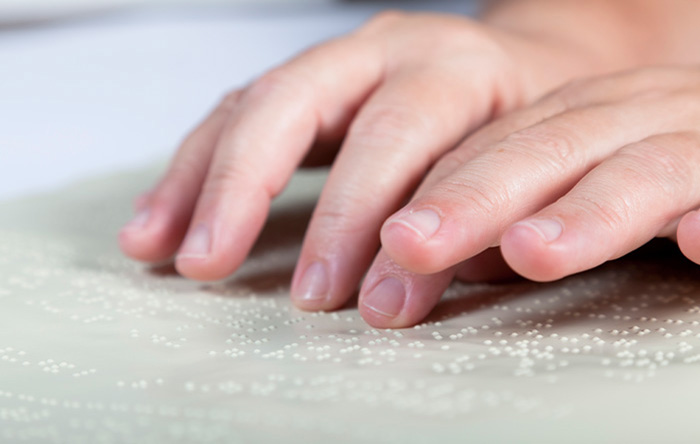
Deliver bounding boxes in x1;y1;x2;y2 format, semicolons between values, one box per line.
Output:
120;0;700;327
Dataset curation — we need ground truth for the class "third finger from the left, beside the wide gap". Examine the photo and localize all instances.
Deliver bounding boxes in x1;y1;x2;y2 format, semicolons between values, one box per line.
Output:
292;55;516;310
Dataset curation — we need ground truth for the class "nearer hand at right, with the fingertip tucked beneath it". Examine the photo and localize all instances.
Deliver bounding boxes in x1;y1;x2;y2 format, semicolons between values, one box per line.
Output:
360;68;700;327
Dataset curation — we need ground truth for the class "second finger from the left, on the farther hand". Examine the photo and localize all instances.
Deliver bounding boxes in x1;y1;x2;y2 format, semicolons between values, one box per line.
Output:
176;38;382;280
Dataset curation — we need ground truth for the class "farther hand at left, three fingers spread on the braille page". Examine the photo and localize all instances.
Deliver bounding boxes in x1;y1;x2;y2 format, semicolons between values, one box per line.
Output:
120;9;632;325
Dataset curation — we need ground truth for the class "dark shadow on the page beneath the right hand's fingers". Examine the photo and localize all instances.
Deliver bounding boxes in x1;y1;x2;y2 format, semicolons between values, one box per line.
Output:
427;240;700;333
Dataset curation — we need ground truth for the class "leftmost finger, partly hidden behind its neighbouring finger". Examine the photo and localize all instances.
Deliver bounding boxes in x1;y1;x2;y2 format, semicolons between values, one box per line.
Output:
119;91;241;262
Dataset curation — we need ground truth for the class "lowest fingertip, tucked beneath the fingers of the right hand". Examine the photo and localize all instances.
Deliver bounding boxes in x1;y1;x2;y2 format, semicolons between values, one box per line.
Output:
358;252;454;328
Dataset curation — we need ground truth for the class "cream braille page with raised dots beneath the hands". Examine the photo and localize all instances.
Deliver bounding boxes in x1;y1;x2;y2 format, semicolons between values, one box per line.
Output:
0;170;700;444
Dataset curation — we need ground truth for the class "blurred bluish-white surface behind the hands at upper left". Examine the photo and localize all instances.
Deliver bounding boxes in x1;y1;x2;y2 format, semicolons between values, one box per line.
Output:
0;1;469;199
